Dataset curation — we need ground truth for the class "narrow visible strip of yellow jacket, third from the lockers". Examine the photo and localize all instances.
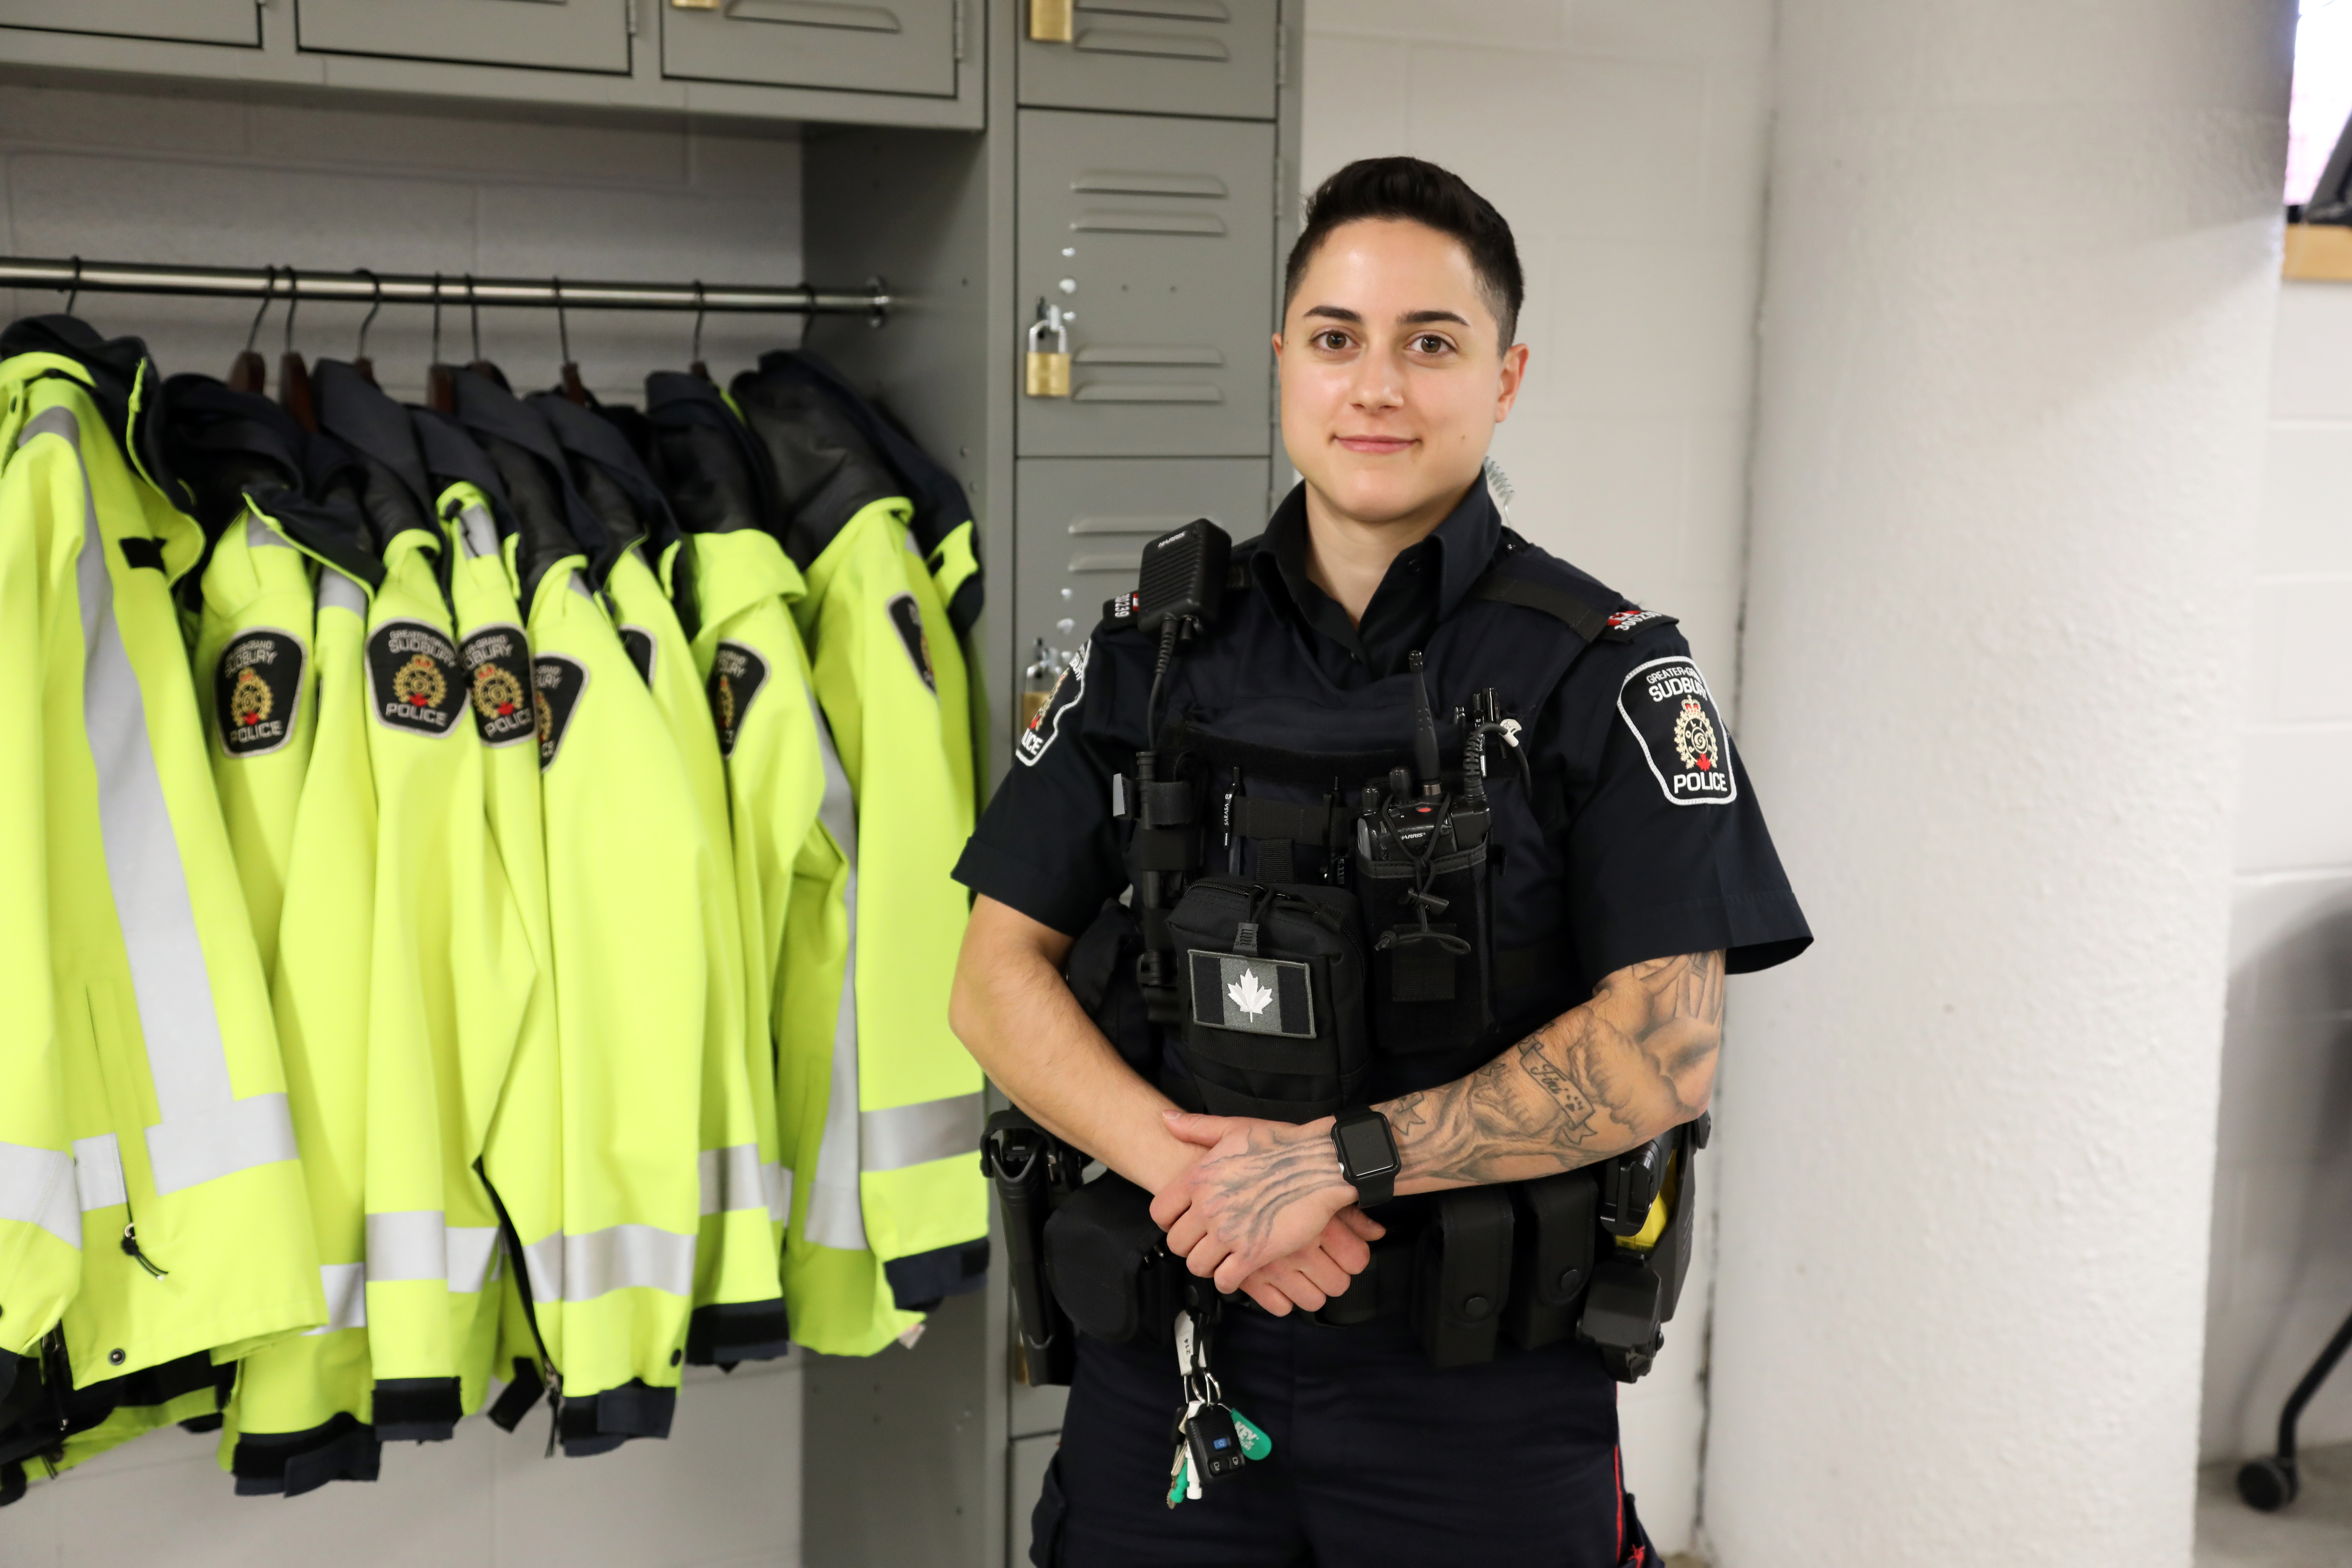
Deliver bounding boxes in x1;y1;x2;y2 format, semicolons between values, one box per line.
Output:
529;393;790;1366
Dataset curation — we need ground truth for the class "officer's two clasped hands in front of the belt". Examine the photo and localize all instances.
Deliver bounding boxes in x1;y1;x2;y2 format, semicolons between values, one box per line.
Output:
1153;1112;1388;1316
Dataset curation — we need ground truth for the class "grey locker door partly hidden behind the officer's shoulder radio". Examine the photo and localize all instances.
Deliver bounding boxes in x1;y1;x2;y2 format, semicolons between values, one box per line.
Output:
1014;458;1265;686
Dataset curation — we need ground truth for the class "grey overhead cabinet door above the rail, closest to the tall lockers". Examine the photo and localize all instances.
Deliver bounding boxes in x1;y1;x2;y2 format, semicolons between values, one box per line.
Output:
661;0;960;99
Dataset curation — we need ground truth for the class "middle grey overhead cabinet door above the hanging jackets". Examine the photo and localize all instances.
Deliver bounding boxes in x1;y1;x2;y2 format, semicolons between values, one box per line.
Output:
296;0;630;73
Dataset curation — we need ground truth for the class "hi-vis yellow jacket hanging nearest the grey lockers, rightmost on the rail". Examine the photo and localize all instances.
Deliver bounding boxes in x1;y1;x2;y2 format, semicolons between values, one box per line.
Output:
732;371;988;1349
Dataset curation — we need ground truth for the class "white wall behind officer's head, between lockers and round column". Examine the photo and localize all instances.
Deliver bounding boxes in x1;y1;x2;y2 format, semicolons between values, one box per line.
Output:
1298;0;1769;1552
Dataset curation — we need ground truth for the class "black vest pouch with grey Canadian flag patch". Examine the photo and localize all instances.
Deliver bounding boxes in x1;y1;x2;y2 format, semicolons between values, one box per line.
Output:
1169;877;1371;1121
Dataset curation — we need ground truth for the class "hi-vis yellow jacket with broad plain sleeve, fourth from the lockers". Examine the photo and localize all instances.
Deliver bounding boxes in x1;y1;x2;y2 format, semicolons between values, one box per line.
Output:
456;371;718;1455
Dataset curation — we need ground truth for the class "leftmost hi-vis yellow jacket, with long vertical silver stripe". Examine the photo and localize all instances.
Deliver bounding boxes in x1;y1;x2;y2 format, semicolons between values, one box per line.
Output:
0;317;324;1448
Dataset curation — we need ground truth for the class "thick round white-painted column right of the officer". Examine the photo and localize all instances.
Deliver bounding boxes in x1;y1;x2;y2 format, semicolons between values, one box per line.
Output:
1705;0;2291;1568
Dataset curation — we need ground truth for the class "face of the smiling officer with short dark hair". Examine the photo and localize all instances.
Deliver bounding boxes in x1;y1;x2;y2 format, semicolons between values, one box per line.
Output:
1275;219;1526;527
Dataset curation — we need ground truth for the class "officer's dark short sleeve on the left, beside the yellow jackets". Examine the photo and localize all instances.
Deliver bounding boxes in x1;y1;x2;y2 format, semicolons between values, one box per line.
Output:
955;637;1143;936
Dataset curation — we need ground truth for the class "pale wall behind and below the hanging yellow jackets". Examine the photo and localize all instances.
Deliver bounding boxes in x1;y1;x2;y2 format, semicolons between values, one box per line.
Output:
0;82;800;1568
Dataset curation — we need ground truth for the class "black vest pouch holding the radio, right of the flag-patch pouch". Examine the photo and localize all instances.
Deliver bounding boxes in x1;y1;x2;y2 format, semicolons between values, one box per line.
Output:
1355;790;1493;1056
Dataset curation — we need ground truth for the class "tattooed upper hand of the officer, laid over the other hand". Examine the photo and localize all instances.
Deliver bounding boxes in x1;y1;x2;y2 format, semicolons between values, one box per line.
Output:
1153;1110;1355;1290
